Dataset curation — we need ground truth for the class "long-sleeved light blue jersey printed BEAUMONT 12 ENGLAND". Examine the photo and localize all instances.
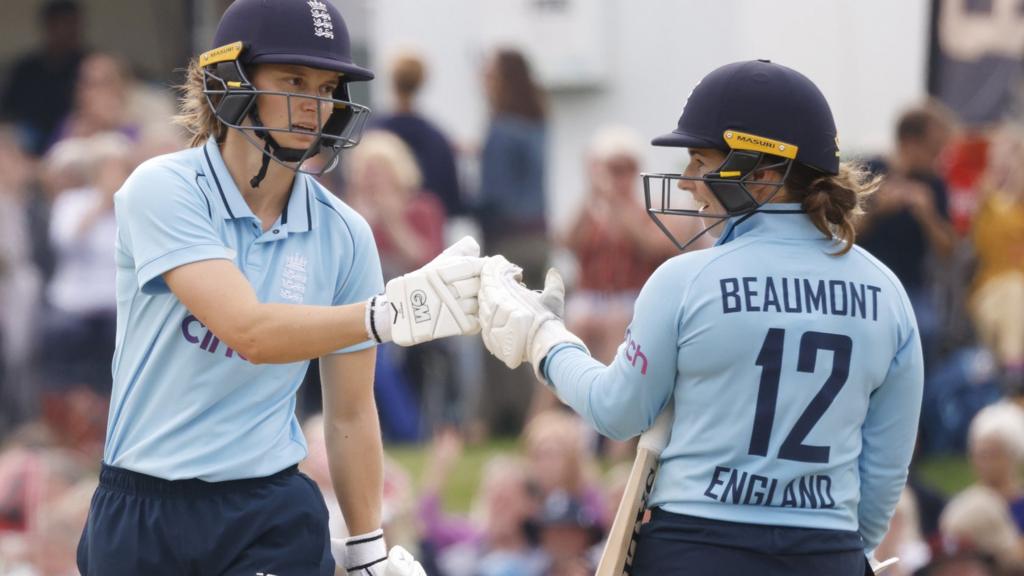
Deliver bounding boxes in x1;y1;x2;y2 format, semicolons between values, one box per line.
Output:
545;204;924;550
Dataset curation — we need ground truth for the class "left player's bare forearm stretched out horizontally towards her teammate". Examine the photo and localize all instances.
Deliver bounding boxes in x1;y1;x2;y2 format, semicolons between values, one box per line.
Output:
230;302;368;364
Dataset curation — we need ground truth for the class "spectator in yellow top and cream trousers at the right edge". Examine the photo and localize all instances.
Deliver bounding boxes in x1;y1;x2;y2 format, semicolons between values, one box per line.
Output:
969;127;1024;396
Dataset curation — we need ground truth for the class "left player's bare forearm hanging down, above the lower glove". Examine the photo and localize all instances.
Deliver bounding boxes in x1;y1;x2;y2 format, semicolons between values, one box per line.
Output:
325;403;384;534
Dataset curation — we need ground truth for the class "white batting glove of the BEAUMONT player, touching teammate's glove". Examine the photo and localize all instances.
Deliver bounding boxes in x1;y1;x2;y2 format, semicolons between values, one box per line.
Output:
479;255;589;381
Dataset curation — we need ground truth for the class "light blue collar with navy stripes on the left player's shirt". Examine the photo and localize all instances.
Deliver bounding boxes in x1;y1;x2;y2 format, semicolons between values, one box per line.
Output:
203;136;313;235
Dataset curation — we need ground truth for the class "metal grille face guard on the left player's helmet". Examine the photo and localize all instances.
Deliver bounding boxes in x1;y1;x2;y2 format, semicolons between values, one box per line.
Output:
200;42;370;175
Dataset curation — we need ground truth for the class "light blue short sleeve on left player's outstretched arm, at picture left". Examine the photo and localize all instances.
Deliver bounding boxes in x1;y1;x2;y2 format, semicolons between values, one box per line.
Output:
115;157;231;294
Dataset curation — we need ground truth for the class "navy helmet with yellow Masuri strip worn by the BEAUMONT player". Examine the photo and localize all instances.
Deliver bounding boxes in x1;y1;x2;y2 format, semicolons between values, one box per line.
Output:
643;59;840;249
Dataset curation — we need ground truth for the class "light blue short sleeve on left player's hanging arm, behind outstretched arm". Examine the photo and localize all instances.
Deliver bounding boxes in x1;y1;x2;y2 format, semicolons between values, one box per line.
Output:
332;207;384;354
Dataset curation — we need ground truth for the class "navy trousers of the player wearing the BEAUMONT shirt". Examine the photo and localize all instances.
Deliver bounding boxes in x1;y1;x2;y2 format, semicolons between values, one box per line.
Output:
630;508;871;576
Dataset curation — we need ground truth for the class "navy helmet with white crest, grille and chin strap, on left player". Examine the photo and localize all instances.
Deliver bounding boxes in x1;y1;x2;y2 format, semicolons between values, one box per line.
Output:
199;0;374;187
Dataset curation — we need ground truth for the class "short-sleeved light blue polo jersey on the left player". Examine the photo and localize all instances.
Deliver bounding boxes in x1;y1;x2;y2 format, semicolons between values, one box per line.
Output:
103;139;383;482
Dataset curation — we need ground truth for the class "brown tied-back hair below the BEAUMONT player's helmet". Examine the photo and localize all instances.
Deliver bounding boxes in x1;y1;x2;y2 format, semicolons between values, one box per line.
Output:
785;162;882;256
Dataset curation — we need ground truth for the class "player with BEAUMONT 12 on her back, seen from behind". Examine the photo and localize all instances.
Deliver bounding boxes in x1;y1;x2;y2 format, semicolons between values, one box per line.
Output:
479;60;924;576
